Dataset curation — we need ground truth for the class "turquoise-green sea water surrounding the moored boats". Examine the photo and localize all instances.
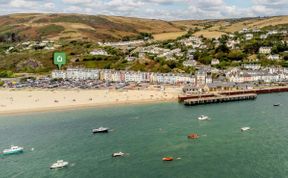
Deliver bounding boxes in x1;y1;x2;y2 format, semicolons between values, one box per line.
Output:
0;93;288;178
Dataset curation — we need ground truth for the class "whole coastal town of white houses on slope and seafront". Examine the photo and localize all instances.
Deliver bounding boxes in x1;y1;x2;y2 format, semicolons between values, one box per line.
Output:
1;26;288;97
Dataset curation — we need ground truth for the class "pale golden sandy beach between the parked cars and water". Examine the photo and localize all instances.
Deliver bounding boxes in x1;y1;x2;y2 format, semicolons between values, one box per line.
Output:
0;88;181;114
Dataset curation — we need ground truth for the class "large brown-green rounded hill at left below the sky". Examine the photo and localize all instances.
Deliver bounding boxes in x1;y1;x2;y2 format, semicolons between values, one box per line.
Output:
0;14;183;41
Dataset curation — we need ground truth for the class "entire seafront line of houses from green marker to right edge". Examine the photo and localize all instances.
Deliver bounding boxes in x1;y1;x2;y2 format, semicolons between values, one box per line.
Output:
51;64;288;87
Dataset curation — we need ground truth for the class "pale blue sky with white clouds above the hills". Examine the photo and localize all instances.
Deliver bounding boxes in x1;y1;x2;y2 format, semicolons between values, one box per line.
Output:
0;0;288;20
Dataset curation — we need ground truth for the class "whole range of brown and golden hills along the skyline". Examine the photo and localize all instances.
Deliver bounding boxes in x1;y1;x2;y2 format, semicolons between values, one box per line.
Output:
0;14;288;41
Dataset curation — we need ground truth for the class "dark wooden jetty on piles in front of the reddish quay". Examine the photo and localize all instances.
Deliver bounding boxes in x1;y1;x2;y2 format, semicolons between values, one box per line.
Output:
184;94;257;106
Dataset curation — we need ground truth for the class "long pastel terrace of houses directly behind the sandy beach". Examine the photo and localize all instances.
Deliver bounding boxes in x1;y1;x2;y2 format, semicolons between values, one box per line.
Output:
52;68;212;85
